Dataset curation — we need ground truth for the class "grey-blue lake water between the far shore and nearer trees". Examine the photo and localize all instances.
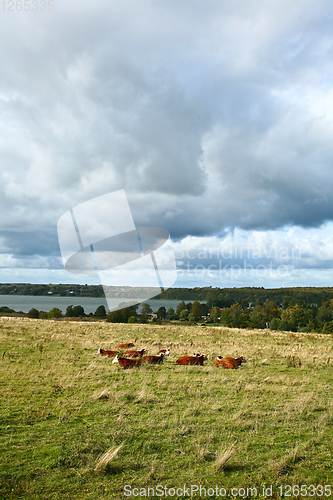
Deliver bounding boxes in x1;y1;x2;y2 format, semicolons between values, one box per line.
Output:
0;295;193;314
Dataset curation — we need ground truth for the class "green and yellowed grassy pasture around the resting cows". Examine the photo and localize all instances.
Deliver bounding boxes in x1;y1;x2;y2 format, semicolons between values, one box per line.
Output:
0;318;333;500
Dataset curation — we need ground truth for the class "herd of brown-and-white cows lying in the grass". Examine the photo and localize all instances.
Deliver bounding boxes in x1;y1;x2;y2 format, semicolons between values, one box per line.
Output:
97;342;246;370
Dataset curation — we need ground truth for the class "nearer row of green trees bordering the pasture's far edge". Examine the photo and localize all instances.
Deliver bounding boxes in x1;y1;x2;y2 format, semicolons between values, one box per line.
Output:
0;295;333;333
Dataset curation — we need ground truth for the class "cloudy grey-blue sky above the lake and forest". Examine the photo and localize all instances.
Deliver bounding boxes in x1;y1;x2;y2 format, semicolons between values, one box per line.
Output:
0;0;333;288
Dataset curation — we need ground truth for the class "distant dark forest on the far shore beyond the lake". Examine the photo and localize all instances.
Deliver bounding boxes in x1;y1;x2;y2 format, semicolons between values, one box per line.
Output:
0;283;333;307
